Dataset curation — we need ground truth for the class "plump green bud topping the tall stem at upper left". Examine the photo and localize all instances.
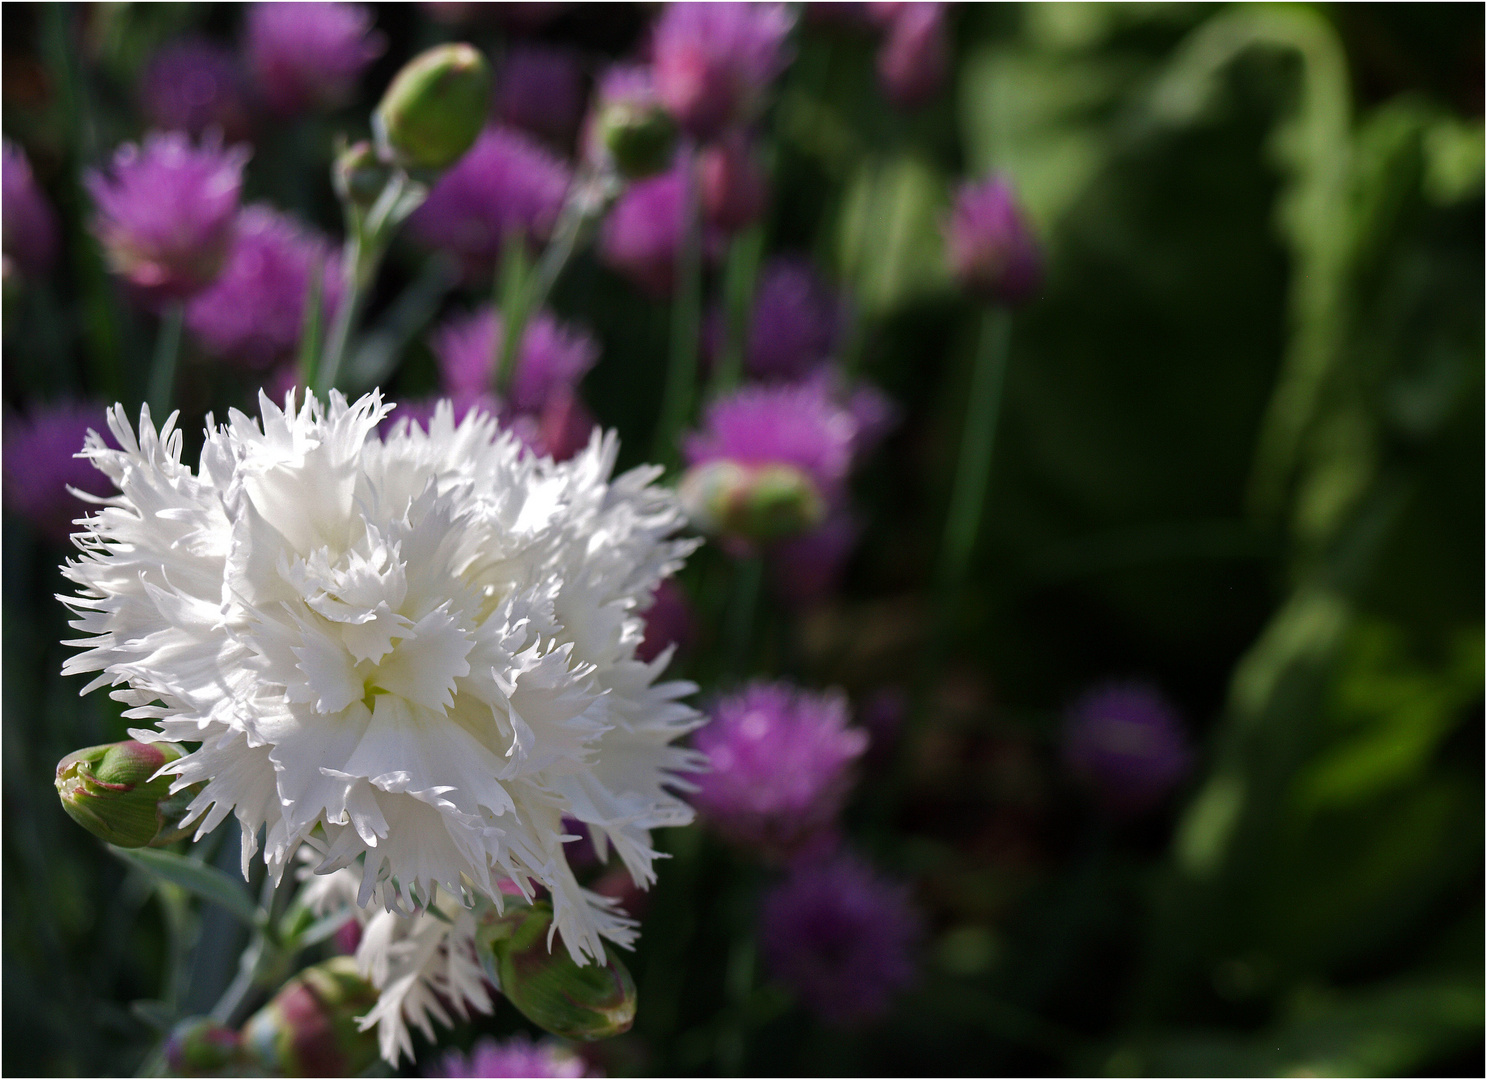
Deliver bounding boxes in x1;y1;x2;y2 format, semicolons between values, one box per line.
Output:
372;45;491;170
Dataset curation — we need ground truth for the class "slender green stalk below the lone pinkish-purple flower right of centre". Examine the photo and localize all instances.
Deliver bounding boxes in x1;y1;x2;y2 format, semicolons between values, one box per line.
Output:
940;306;1011;603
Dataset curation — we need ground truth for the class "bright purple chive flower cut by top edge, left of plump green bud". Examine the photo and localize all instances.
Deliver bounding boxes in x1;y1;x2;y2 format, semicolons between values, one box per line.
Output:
245;3;387;116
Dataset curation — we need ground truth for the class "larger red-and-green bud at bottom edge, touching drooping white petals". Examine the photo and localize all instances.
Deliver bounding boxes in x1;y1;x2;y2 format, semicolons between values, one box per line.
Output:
242;957;378;1076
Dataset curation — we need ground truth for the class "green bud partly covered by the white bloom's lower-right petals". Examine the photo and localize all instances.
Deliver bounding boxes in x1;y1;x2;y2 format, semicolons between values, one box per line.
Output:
476;901;635;1043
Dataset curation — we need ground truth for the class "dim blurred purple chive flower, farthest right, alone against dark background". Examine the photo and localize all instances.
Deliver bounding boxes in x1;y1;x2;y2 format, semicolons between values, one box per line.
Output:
1063;683;1193;814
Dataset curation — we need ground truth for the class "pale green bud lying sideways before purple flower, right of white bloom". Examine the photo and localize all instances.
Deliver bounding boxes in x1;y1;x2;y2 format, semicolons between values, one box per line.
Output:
677;460;827;543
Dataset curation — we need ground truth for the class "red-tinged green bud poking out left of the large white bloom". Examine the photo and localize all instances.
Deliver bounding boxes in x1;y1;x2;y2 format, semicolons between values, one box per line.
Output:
57;739;199;848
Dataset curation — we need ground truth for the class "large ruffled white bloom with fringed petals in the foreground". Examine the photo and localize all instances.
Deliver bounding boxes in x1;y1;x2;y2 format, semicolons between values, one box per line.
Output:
62;391;700;962
